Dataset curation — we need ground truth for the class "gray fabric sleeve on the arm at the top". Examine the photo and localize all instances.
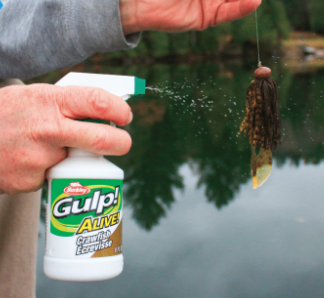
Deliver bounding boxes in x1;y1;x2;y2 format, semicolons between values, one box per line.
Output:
0;0;140;78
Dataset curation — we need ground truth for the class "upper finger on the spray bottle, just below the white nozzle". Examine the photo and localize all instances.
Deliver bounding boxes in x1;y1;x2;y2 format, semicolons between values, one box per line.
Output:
56;86;133;126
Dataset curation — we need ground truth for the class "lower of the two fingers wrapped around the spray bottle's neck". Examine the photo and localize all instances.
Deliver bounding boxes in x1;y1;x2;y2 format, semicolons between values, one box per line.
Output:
55;119;132;155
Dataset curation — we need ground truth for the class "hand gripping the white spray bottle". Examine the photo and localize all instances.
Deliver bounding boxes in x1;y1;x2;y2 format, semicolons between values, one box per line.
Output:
0;84;132;194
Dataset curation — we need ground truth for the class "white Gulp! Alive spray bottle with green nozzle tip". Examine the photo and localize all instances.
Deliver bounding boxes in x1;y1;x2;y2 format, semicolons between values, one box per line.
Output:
44;73;145;281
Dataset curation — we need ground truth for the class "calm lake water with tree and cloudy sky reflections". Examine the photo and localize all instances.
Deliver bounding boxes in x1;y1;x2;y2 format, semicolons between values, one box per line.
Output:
31;59;324;298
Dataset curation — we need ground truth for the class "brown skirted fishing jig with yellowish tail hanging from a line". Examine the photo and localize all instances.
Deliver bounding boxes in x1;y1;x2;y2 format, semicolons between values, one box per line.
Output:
239;64;281;188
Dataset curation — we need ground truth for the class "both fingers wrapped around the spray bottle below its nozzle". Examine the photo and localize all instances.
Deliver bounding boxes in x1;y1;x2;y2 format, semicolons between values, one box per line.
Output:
56;86;133;155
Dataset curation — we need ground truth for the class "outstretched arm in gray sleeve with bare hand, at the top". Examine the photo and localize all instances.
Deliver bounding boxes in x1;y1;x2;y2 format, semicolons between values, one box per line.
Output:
0;0;261;78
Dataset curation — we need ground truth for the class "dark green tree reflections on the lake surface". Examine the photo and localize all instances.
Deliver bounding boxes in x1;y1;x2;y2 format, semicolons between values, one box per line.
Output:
32;62;324;230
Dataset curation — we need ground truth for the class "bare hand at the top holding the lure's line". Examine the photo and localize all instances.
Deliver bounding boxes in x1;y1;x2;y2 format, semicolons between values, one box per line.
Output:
119;0;261;35
